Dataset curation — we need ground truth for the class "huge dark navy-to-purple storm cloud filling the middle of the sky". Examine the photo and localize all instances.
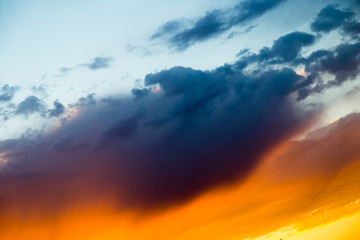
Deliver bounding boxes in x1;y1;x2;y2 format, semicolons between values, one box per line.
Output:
0;60;316;212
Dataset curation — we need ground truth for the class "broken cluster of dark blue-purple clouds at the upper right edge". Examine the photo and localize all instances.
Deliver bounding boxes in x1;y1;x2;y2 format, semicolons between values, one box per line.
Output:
232;5;360;101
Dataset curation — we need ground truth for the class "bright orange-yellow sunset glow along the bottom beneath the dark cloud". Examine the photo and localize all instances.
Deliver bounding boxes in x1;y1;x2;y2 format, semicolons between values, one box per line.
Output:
0;142;360;240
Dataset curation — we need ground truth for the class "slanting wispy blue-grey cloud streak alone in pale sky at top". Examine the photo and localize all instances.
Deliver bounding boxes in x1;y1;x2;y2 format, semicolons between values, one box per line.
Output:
152;0;283;51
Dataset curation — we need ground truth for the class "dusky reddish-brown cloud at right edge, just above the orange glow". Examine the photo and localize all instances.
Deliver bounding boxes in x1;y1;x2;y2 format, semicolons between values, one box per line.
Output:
274;113;360;179
